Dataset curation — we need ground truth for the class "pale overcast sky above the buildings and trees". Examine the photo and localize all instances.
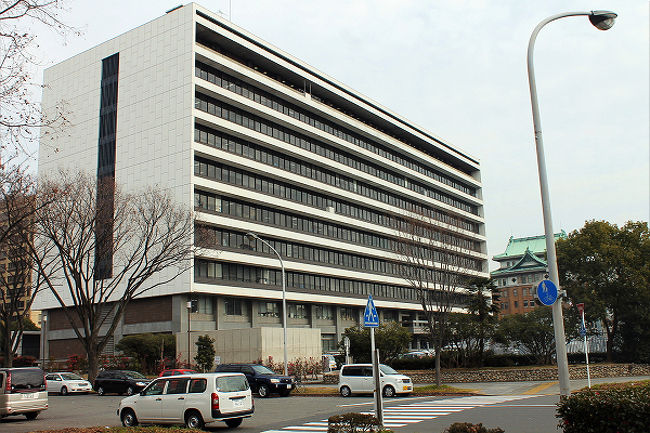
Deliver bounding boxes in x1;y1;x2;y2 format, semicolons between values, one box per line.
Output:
31;0;650;268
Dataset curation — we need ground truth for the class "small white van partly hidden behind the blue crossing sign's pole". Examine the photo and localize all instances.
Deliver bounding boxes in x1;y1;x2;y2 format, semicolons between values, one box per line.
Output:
339;364;413;397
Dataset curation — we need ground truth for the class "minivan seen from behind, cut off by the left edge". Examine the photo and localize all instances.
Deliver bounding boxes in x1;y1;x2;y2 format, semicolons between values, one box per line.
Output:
0;367;48;420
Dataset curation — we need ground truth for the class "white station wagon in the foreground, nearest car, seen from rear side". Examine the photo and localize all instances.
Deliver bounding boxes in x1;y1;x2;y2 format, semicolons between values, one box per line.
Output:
117;373;255;429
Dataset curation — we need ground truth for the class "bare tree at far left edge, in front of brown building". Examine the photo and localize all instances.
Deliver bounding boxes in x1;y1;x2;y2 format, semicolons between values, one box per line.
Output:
0;166;58;367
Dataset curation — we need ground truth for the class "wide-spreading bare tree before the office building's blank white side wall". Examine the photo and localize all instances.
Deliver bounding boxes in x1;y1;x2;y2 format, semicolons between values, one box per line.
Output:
33;173;194;379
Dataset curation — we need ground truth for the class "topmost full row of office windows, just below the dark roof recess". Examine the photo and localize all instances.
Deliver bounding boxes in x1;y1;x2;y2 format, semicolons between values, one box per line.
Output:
195;61;476;196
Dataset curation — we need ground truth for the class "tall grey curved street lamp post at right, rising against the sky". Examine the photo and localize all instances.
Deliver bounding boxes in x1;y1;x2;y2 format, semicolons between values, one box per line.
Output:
528;11;617;396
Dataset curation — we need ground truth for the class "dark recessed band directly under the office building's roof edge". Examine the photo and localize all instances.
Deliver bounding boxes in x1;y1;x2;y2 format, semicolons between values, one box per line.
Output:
196;25;474;174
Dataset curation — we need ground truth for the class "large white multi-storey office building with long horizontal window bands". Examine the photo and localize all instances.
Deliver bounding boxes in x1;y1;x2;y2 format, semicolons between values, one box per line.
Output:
37;3;488;358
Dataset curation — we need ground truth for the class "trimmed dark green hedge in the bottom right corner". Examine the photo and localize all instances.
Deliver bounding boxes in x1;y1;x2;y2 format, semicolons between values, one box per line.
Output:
556;381;650;433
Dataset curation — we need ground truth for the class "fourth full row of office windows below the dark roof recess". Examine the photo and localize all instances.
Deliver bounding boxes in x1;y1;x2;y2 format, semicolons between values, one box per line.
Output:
194;157;478;236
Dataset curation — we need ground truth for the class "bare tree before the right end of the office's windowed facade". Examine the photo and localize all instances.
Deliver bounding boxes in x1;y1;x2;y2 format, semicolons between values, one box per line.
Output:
397;210;473;385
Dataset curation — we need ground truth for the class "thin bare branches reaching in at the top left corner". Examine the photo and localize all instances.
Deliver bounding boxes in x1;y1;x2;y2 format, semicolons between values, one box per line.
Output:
0;0;74;154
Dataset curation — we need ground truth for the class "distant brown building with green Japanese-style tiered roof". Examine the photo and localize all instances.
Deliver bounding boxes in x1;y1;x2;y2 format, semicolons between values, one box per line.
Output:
490;231;566;315
